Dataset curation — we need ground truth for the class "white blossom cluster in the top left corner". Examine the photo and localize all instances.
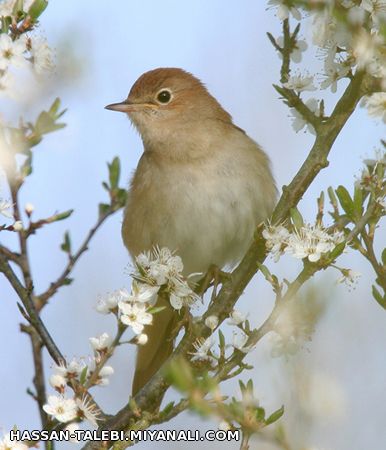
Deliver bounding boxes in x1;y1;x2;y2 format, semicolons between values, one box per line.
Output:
0;0;53;96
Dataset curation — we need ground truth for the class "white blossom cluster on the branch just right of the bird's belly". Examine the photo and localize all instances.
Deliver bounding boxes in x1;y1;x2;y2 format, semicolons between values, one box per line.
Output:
263;224;344;262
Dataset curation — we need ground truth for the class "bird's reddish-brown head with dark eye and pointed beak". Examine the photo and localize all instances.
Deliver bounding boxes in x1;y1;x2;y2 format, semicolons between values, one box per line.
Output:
106;68;231;148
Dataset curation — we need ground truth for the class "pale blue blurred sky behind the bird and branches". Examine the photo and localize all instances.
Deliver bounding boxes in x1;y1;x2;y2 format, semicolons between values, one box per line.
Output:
0;0;386;450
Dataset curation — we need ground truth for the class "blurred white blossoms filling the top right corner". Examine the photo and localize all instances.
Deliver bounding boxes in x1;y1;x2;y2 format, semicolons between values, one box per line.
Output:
268;0;386;125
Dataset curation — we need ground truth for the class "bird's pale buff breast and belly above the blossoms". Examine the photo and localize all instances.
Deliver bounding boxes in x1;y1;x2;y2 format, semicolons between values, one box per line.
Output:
122;142;274;273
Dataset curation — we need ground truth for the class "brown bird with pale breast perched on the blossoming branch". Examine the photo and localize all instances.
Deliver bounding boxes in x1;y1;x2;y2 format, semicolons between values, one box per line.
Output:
106;67;277;395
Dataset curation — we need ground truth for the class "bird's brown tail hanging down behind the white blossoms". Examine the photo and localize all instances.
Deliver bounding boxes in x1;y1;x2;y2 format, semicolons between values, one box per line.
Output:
132;297;176;395
